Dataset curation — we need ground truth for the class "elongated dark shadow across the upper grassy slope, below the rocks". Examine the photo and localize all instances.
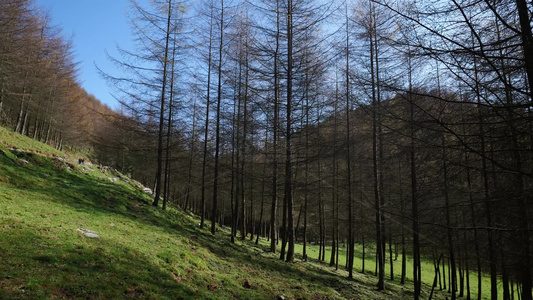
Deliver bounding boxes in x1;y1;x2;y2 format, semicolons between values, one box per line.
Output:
0;152;186;231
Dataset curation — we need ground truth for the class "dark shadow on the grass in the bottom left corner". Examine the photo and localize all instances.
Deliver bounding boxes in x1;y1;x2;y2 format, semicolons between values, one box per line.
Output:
0;229;194;299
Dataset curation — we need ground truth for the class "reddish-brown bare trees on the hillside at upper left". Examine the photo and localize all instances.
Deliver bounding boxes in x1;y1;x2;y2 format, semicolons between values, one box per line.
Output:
0;0;112;149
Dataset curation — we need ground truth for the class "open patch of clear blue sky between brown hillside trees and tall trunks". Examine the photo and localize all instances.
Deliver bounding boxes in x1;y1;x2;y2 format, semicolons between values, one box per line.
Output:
35;0;142;108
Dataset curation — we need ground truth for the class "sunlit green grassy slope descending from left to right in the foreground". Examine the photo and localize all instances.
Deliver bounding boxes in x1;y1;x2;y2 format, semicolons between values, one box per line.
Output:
0;128;456;299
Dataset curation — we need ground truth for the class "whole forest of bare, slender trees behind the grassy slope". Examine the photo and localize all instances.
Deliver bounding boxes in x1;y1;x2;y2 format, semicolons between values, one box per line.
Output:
0;0;533;300
